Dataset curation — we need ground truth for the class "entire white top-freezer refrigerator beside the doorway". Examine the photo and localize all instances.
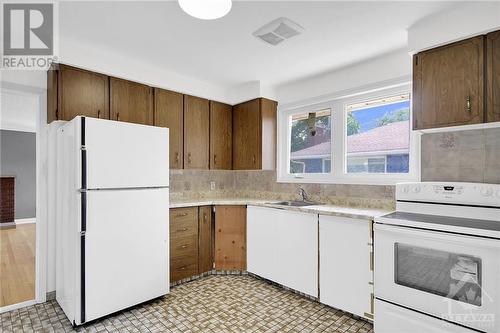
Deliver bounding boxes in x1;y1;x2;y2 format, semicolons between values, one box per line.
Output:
56;117;170;325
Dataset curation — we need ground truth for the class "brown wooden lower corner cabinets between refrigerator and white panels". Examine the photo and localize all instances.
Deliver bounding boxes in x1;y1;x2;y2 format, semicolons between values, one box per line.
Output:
170;206;247;283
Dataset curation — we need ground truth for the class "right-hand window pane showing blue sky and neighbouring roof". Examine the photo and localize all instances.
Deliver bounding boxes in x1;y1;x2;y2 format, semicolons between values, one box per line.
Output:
345;94;410;173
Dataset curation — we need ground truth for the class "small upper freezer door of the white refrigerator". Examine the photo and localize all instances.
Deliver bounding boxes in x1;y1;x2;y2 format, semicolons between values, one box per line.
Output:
84;117;169;189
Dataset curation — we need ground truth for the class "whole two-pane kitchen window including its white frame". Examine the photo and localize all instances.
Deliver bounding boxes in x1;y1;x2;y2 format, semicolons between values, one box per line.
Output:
278;84;419;184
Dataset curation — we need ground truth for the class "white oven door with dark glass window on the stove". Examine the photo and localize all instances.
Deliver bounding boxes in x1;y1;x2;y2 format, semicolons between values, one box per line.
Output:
374;224;500;333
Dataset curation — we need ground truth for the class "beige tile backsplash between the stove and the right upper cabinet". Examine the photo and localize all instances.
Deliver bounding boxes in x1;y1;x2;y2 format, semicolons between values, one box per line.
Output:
421;128;500;184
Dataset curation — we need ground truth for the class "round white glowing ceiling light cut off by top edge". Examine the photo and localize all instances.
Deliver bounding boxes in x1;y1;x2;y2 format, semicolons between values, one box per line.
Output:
179;0;232;20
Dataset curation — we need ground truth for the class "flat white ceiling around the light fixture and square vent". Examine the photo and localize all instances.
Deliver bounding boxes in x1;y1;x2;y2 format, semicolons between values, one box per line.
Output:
59;1;458;86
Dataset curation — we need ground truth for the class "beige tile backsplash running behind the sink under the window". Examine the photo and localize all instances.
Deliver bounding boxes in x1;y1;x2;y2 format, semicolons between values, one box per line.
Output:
170;170;394;209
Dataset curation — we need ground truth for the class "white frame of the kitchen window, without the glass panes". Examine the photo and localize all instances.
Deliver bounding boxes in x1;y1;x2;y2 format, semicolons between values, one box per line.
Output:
277;83;421;185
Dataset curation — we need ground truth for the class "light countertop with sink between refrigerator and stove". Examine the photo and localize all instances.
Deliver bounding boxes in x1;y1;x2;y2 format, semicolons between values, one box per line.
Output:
170;198;389;220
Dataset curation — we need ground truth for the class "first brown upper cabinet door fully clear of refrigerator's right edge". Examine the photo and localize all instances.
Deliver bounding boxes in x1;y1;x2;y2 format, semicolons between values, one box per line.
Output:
184;95;210;169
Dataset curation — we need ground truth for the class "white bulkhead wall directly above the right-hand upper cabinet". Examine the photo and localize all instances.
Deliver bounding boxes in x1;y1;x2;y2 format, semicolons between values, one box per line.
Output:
408;1;500;53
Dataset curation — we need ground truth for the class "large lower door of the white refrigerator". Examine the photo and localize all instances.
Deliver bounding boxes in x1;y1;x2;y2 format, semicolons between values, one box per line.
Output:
84;188;169;322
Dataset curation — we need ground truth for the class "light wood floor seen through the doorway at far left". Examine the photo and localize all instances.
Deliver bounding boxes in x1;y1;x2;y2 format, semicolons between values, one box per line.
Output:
0;223;35;307
